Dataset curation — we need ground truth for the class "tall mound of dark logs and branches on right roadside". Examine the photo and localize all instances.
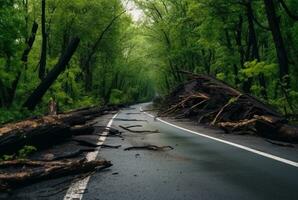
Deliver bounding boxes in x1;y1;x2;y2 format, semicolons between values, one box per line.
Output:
158;72;298;143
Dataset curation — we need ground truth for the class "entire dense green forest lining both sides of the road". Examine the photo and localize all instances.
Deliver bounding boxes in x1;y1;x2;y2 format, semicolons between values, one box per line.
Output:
0;0;298;122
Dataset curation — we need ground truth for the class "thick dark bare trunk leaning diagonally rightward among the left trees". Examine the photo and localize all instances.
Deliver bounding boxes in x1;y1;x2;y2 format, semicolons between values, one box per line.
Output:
23;38;80;110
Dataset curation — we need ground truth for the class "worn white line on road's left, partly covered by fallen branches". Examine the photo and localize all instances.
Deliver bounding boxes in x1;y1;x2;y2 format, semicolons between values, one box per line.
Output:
64;113;118;200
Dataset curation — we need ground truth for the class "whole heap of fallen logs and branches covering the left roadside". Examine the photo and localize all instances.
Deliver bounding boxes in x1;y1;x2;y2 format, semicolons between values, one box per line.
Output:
0;107;121;191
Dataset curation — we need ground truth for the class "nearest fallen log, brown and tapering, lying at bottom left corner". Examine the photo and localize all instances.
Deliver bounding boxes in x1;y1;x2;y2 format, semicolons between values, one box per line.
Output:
0;159;112;191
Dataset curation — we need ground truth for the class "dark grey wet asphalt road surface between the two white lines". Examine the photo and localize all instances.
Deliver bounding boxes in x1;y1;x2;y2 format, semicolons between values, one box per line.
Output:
65;106;298;200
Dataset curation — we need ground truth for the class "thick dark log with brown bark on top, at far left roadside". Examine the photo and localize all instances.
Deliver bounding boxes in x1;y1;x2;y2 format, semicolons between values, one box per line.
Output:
0;117;71;155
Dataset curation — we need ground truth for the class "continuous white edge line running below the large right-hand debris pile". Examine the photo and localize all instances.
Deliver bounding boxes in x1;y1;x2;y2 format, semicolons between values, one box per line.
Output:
140;107;298;167
